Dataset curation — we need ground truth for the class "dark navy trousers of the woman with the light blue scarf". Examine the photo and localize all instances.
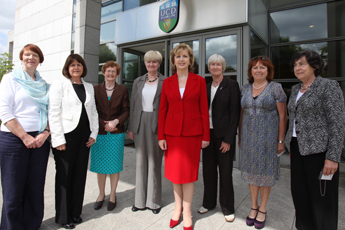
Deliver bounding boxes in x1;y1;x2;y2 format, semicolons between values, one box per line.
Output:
0;131;50;230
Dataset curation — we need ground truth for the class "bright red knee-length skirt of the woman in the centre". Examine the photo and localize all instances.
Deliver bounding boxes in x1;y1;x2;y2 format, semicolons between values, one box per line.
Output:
165;135;202;184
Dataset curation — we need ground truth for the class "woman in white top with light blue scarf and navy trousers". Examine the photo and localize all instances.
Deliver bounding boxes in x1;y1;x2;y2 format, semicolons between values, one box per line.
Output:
0;44;50;229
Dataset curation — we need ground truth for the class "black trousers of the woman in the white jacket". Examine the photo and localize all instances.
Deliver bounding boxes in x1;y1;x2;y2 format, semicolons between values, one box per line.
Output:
53;125;90;224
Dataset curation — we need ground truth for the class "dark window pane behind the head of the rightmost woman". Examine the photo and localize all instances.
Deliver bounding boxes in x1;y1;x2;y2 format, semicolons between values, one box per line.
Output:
271;40;345;79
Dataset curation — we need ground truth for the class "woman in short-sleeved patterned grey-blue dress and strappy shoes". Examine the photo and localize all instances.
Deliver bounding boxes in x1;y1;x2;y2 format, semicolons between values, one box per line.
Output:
239;56;286;229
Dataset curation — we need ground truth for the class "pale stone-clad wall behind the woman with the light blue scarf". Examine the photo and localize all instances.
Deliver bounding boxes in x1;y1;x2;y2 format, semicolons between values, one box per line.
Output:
13;0;73;83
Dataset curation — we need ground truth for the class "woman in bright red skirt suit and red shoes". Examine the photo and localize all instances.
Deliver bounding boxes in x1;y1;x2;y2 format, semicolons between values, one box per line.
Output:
158;43;210;230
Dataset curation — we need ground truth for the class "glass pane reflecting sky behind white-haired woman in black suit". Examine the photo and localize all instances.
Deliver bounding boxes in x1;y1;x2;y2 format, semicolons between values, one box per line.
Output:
205;35;237;73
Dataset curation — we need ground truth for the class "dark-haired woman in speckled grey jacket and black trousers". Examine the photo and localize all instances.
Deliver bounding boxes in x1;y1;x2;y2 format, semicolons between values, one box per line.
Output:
284;50;345;230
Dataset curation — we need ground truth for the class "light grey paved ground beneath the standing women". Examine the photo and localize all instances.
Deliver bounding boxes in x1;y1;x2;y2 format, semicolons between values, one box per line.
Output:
0;147;345;230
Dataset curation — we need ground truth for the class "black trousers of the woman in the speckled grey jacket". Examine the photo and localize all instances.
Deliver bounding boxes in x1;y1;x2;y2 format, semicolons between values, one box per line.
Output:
291;138;339;230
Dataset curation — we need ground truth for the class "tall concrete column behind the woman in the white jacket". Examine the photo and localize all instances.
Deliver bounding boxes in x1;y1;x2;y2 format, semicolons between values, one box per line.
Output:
74;0;102;84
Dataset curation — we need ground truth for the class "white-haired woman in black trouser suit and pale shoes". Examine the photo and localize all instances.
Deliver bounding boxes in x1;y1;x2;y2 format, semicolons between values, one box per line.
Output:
198;54;241;222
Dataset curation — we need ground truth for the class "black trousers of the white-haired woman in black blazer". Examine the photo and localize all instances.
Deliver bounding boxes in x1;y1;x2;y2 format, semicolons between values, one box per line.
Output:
202;129;236;215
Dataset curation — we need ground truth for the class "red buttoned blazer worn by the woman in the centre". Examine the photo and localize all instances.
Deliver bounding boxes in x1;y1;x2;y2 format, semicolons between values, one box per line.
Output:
158;72;210;141
